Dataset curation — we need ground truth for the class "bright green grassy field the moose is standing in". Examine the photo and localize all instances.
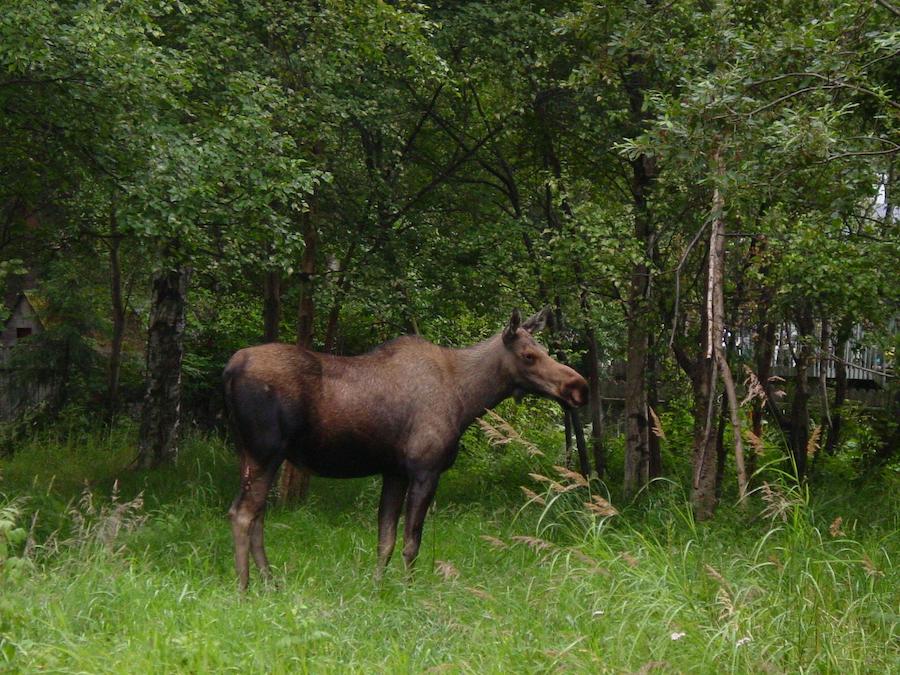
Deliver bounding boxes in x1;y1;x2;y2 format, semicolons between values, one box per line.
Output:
0;430;900;673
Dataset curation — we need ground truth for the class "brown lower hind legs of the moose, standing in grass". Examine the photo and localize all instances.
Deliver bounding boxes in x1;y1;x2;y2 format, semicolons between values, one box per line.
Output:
228;455;279;591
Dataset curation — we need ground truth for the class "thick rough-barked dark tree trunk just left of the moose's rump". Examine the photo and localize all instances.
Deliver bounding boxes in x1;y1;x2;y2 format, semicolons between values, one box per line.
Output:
133;267;190;469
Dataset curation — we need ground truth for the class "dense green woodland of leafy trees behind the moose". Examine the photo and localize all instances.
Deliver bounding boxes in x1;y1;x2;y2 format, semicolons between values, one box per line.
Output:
0;0;900;672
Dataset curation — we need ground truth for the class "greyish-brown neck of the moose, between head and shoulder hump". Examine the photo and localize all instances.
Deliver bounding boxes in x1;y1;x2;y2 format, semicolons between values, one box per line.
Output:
453;335;514;429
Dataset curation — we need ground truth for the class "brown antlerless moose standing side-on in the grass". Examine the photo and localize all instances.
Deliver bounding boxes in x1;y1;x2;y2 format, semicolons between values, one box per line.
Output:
224;308;588;591
